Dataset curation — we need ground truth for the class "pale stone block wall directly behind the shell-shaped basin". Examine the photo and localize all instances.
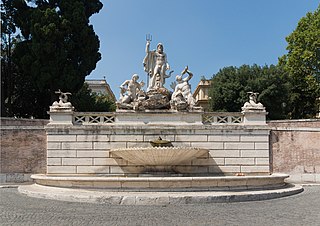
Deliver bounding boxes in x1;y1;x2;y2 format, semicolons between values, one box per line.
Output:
46;124;270;175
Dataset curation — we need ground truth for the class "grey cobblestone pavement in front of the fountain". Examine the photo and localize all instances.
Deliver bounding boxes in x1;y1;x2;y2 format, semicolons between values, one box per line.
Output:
0;186;320;226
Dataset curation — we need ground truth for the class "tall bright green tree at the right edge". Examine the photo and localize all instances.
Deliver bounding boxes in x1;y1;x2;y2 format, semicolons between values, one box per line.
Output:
279;5;320;118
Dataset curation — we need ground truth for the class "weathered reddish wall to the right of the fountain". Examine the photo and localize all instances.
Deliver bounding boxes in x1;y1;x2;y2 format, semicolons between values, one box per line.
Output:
268;119;320;183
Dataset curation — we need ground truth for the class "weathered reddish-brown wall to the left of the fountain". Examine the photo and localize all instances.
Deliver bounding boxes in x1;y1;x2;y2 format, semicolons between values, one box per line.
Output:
0;118;49;182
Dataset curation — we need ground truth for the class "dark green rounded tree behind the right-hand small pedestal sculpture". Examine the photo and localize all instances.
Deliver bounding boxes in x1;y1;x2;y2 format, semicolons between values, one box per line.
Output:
209;65;288;119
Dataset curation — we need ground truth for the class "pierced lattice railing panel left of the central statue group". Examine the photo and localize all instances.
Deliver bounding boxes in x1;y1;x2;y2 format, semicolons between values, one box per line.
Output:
73;112;116;125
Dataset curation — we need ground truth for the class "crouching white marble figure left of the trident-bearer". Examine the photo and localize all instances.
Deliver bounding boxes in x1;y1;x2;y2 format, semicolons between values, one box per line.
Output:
118;74;145;104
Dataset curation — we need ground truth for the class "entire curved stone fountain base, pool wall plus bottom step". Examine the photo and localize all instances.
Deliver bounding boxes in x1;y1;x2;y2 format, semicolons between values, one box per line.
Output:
18;174;303;205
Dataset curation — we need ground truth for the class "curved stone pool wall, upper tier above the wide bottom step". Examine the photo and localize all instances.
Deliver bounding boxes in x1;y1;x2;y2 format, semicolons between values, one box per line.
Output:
31;174;288;192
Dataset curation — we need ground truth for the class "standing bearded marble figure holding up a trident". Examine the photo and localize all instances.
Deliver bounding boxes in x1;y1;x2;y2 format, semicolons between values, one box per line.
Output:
143;35;172;90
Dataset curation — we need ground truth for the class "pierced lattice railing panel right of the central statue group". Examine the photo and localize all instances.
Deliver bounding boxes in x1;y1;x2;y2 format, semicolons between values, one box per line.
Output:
202;112;244;124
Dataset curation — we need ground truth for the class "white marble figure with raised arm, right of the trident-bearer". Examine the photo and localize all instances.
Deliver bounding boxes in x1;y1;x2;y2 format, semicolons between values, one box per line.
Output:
171;66;195;110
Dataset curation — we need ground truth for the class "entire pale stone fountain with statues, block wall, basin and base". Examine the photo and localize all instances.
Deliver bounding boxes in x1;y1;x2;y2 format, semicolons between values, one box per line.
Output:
19;36;302;205
